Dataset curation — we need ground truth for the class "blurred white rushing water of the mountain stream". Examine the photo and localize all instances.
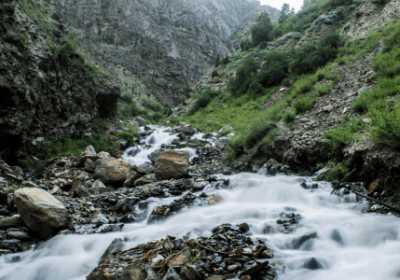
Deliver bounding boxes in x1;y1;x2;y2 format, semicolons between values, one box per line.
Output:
0;129;400;280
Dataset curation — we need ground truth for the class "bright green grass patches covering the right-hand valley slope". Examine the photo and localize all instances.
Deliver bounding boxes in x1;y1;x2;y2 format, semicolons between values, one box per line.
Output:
178;0;400;165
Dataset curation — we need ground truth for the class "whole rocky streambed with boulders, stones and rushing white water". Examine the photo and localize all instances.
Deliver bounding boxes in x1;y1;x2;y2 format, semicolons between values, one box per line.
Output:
0;123;398;279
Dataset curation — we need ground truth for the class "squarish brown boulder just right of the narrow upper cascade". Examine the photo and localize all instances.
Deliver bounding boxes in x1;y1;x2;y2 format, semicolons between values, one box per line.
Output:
154;150;189;180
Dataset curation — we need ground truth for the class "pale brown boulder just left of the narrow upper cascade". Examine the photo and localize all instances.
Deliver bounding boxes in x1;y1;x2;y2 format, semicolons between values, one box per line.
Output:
94;158;131;185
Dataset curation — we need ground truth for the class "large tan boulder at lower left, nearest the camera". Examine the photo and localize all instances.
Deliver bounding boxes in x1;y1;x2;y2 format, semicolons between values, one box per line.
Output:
14;188;75;239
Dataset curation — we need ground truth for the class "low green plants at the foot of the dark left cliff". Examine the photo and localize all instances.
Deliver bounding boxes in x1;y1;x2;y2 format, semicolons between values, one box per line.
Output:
33;123;119;159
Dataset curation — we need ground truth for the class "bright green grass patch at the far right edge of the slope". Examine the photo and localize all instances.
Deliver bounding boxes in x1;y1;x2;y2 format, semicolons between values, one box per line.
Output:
324;20;400;149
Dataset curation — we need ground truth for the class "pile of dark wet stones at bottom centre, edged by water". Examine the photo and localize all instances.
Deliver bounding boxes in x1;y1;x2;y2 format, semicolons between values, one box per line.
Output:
87;223;276;280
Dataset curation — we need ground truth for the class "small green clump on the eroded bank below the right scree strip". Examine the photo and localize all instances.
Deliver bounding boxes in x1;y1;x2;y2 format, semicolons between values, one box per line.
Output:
324;116;365;150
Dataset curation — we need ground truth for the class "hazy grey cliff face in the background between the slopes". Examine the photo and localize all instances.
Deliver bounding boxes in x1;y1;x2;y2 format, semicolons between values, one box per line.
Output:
53;0;277;106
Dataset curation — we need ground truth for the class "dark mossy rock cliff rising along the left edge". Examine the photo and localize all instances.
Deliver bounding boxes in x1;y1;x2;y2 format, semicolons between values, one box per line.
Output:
0;0;119;161
